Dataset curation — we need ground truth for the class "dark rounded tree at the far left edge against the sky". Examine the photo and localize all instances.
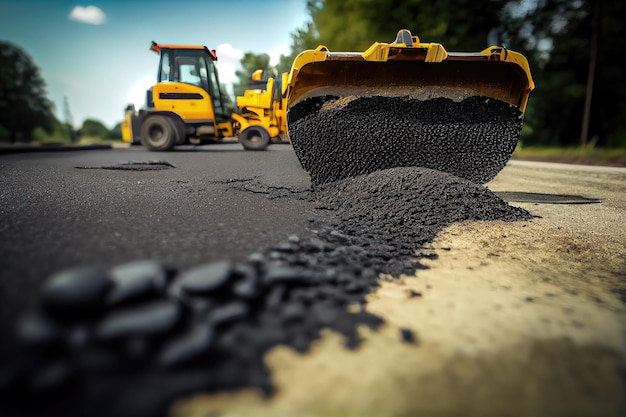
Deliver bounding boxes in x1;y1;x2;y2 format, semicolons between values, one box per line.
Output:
0;41;54;143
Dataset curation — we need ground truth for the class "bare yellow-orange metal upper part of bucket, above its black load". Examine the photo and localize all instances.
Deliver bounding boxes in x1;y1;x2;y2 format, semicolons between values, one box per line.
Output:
287;29;535;112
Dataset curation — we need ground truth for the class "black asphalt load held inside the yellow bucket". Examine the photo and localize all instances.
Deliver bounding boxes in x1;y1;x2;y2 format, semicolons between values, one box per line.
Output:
287;96;523;184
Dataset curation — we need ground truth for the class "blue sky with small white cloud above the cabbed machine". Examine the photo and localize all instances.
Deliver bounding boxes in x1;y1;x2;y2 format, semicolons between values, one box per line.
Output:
0;0;308;128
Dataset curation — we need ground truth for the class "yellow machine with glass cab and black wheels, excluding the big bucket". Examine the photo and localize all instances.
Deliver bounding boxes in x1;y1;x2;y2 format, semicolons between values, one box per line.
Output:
122;42;278;151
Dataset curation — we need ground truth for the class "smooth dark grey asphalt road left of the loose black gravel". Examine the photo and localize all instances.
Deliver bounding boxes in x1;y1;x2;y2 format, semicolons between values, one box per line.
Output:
0;143;329;338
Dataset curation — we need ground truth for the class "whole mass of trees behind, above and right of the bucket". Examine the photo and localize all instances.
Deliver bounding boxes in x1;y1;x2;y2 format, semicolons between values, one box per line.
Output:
280;0;626;146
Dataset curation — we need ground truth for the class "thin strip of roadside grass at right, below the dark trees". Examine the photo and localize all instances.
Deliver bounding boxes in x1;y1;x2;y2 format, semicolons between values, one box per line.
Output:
512;146;626;167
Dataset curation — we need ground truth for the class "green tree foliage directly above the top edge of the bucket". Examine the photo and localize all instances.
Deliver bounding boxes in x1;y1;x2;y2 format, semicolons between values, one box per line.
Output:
307;0;507;51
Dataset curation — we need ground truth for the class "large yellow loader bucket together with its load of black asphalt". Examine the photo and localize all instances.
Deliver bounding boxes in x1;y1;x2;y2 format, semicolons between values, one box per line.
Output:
287;29;534;184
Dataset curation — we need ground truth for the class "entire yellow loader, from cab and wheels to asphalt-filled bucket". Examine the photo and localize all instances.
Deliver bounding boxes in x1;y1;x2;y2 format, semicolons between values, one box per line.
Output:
123;29;534;183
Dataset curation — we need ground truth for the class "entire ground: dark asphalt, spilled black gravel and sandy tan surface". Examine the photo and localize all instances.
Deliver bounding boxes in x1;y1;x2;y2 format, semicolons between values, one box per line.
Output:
0;145;626;416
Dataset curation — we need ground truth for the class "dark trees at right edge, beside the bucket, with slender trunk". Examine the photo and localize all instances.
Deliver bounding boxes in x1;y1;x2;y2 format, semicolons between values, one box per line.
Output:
499;0;626;146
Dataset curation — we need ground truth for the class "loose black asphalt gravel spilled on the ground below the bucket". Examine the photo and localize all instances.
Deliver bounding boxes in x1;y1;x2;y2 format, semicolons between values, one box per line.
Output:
0;167;531;417
